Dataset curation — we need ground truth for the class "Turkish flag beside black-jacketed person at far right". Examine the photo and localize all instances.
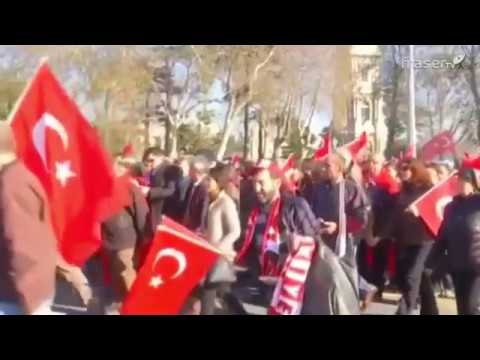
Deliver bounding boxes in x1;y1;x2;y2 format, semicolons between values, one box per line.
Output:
411;175;458;236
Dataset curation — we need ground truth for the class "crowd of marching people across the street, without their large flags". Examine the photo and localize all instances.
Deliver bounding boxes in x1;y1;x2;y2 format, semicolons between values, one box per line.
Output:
0;119;480;315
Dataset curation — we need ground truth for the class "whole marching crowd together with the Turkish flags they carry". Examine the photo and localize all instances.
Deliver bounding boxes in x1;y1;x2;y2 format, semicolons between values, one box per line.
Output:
0;66;480;315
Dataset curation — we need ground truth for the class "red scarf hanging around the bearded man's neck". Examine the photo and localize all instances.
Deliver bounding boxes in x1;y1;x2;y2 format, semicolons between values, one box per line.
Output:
236;198;281;276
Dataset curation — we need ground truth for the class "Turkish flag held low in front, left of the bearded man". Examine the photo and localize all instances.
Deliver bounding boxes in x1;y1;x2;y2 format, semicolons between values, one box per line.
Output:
122;219;220;315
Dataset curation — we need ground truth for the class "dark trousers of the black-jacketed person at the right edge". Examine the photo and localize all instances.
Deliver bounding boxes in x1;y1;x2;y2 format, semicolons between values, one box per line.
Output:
452;272;480;315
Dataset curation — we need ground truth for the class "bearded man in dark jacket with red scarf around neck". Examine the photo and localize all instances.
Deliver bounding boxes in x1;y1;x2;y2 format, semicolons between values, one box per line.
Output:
237;165;359;315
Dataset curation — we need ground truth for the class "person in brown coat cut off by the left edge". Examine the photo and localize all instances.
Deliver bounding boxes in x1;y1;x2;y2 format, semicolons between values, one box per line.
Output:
0;124;58;315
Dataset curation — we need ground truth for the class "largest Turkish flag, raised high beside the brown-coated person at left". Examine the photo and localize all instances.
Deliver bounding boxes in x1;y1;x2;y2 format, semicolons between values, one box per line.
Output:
11;64;130;266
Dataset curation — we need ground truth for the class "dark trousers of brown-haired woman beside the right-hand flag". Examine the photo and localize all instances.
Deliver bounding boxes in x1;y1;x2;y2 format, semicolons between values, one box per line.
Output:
397;242;434;315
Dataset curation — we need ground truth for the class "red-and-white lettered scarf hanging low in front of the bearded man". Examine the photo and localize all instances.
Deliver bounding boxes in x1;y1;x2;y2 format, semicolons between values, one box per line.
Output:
268;235;315;315
